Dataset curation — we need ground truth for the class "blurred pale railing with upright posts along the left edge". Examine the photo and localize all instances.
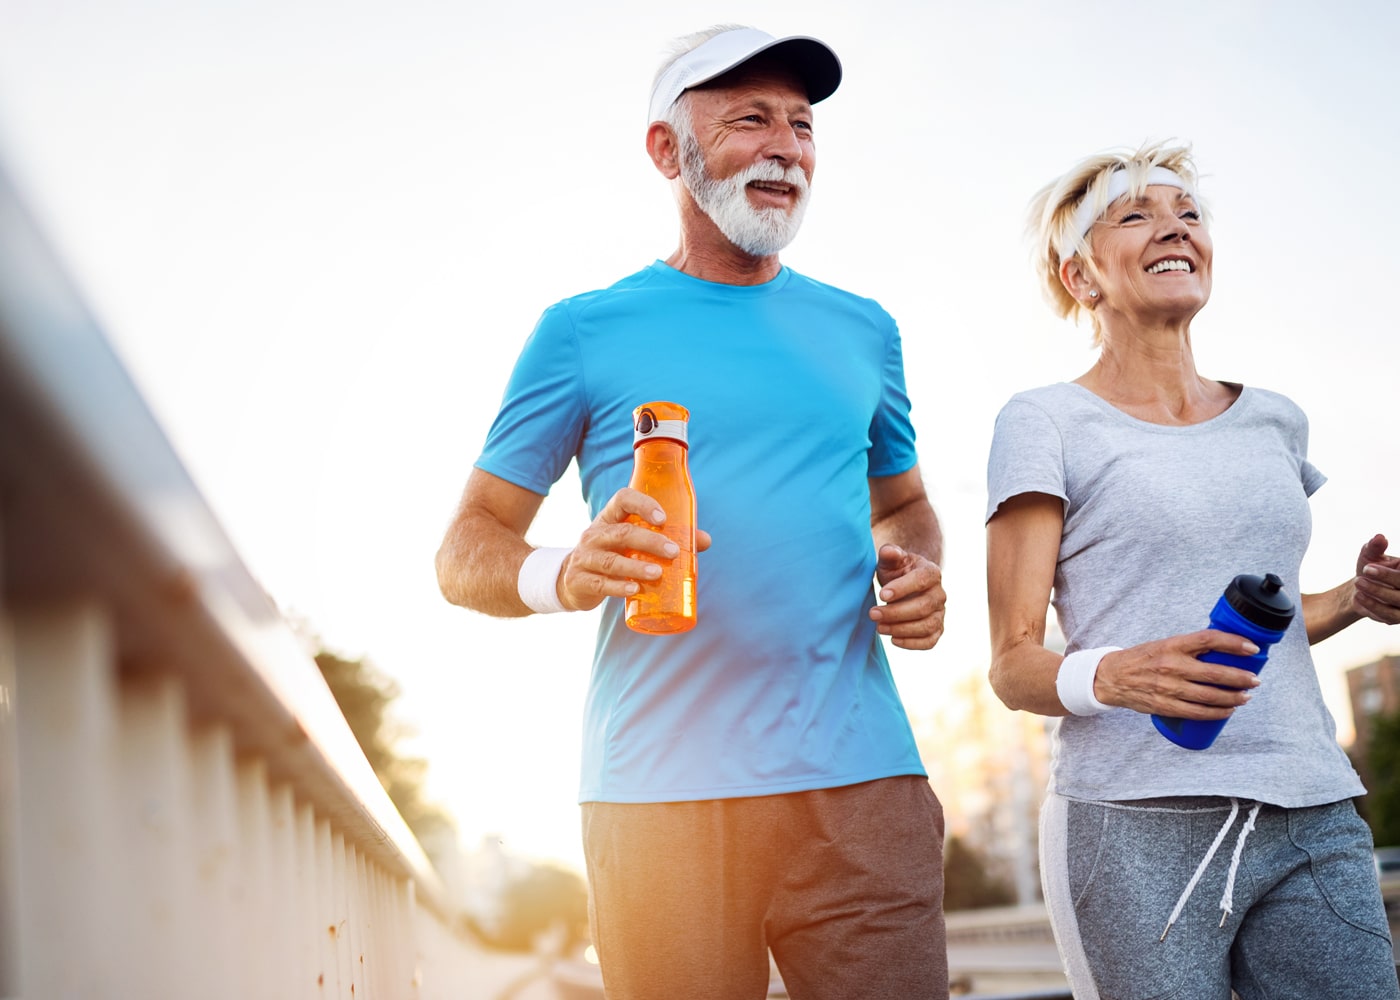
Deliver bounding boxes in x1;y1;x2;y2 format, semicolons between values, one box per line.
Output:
0;159;472;1000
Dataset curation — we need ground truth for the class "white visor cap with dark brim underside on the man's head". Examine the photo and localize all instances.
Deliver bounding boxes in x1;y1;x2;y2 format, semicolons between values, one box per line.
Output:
647;28;841;125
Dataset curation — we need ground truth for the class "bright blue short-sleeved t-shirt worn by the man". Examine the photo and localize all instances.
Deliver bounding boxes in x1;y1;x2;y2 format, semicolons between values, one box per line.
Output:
476;261;925;803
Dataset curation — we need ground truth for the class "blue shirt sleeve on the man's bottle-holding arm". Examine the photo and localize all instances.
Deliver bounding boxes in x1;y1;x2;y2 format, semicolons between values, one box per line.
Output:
476;303;587;496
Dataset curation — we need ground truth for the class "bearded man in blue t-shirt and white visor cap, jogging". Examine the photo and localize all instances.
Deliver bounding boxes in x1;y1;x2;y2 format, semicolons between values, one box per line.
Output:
437;27;948;1000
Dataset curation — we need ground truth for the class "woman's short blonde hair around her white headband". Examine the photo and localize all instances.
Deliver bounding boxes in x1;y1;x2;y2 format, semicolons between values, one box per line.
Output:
1026;140;1210;345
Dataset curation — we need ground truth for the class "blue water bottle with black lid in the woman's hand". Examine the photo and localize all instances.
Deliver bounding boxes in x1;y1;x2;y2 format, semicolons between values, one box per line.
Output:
1152;573;1294;749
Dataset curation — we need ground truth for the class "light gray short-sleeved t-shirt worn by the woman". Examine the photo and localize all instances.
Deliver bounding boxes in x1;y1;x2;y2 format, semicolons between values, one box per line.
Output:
987;382;1364;807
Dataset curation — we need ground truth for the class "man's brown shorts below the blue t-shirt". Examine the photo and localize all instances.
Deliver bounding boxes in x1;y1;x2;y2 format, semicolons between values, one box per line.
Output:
582;776;948;1000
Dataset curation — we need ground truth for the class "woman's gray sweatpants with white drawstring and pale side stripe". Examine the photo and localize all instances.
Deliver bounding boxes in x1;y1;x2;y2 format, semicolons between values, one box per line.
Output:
1040;796;1400;1000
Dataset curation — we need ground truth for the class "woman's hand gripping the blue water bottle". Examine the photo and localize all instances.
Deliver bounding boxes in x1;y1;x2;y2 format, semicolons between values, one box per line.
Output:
1093;629;1259;720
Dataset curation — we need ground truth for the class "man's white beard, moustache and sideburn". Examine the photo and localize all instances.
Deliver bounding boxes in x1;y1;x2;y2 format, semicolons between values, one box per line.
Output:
678;129;809;256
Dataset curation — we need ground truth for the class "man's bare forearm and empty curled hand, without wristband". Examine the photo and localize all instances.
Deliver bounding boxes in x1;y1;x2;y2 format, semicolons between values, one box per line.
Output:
869;465;948;650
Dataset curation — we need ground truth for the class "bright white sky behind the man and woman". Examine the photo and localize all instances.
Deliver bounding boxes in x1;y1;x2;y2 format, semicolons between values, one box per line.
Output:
0;0;1400;863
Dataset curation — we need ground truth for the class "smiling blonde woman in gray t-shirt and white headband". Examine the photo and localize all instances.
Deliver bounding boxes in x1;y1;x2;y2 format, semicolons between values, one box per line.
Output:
987;144;1400;1000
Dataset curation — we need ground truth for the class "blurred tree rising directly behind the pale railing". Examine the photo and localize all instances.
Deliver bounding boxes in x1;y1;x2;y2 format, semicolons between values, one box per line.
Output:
316;650;452;840
